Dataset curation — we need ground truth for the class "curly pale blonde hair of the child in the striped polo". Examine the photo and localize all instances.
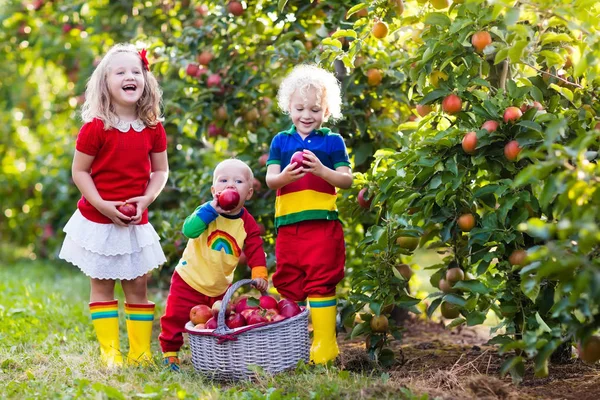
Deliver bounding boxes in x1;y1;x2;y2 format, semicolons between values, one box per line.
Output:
277;64;342;120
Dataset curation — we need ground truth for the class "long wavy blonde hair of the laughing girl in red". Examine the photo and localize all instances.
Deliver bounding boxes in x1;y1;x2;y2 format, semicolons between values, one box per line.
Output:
81;44;162;130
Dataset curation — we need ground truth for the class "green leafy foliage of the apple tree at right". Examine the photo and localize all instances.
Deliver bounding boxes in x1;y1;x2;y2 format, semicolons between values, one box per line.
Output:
326;1;600;380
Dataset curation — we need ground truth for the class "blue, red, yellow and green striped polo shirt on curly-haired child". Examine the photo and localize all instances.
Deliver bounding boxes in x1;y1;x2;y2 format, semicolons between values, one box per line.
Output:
267;126;350;228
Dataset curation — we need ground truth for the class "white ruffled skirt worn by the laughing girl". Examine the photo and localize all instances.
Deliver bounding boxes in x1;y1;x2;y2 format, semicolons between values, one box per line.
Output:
58;210;167;280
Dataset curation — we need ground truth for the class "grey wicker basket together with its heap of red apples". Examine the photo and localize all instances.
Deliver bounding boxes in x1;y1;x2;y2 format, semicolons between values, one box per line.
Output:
186;279;309;380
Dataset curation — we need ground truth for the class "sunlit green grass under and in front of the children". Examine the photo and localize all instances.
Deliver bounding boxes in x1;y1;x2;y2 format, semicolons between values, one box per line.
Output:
0;262;427;399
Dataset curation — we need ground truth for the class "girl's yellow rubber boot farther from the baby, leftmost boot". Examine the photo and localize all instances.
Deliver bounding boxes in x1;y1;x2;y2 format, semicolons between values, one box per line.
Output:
89;300;123;368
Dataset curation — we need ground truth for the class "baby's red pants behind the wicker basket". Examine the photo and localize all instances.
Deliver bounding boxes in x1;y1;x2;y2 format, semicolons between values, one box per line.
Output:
158;271;225;353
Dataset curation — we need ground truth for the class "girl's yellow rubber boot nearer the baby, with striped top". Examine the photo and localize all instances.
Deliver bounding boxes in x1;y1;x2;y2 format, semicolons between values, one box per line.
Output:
125;303;155;365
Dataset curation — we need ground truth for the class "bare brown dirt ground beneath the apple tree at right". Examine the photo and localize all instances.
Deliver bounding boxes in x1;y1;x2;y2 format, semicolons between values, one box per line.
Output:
338;318;600;400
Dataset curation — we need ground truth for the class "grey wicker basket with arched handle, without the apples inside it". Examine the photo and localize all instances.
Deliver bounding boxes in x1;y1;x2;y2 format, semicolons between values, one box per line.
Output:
186;279;309;380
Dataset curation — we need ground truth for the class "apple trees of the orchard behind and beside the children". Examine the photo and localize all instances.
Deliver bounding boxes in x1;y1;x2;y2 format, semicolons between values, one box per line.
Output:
0;0;600;396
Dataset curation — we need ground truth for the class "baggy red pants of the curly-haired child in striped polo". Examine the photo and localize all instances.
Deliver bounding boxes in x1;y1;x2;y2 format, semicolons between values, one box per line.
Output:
273;220;346;301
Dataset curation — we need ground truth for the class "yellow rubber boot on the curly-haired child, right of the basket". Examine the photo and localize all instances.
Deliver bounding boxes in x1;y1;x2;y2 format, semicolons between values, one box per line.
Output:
308;296;340;364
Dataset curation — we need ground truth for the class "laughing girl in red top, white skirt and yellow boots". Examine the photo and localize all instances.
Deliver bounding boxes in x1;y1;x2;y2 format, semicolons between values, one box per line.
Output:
59;44;169;367
